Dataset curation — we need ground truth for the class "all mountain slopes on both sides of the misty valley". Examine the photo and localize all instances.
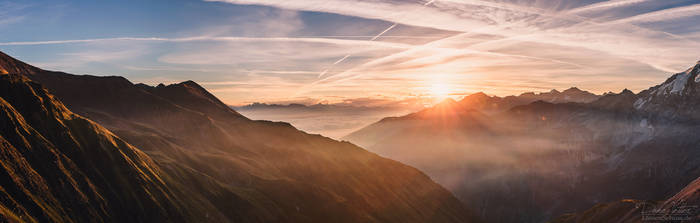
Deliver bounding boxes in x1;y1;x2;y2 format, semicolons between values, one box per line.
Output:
0;48;700;222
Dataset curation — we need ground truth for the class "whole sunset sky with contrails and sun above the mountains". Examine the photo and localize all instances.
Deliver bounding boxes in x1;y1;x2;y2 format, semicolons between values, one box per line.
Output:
0;0;700;105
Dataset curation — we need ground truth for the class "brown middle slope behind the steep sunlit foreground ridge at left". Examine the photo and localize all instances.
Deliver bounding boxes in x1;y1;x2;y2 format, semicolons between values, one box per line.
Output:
0;51;474;222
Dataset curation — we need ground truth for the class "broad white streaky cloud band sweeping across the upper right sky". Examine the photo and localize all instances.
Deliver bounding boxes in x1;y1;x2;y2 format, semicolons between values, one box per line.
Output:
209;0;698;76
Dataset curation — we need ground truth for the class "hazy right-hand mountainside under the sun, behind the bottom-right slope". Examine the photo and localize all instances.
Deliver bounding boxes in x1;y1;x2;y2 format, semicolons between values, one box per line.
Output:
345;61;700;222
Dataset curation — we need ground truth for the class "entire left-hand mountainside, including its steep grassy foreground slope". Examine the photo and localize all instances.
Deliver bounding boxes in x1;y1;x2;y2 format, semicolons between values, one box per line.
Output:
0;51;475;222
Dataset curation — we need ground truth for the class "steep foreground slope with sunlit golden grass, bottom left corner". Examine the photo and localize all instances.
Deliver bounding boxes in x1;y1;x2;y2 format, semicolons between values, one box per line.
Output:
0;74;253;222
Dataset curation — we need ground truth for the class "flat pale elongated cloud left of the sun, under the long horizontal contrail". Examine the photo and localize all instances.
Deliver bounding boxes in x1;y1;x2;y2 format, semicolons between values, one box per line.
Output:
154;38;404;66
